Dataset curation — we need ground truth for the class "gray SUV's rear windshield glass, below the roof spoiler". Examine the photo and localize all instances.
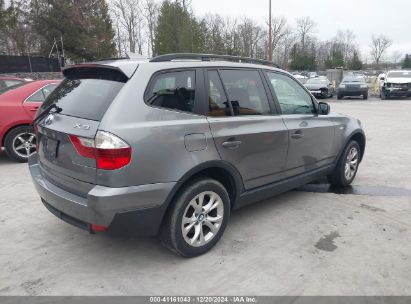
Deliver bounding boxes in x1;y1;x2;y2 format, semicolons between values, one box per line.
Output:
42;79;124;121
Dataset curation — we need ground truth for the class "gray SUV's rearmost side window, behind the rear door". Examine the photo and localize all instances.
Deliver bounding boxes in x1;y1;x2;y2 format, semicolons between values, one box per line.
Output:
146;71;195;112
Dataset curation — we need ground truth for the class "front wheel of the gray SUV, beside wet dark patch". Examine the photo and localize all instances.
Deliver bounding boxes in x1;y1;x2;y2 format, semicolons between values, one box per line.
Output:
327;140;361;187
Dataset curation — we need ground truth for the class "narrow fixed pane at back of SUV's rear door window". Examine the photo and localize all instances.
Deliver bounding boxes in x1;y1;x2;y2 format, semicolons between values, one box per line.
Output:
208;70;231;116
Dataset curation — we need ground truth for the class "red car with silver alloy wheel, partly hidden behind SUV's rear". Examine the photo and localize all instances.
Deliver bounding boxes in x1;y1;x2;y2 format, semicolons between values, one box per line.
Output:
0;80;60;162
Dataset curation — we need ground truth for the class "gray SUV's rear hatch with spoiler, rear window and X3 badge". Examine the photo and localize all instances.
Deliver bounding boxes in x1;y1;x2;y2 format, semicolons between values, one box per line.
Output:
37;65;135;196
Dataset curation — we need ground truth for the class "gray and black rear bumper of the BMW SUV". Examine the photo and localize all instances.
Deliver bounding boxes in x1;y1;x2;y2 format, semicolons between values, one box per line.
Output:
29;154;176;235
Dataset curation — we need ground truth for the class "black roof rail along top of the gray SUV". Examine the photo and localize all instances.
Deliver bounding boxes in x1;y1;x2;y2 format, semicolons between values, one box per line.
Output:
150;53;281;69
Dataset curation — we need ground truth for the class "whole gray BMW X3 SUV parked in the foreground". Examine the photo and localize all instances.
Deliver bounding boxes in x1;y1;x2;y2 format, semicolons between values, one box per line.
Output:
29;54;365;257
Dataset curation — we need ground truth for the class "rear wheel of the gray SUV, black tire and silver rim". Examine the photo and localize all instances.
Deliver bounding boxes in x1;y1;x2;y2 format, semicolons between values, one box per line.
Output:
159;178;230;258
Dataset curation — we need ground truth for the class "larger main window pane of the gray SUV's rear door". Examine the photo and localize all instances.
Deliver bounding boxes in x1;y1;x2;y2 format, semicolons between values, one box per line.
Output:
221;70;270;115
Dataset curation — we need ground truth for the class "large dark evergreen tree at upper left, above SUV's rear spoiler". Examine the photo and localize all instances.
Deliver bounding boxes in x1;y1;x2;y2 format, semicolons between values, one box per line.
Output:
31;0;116;61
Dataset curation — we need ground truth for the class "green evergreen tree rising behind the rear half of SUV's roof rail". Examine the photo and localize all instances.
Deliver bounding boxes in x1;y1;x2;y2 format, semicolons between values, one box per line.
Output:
154;0;205;55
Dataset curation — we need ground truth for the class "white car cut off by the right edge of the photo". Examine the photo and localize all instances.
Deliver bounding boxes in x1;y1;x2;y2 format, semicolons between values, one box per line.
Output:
380;70;411;100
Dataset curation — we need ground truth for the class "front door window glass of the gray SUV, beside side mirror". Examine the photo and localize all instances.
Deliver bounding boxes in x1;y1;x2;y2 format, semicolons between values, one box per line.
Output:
267;72;315;114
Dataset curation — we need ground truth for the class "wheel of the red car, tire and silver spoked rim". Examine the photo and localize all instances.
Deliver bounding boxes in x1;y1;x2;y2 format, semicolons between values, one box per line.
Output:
4;126;36;163
